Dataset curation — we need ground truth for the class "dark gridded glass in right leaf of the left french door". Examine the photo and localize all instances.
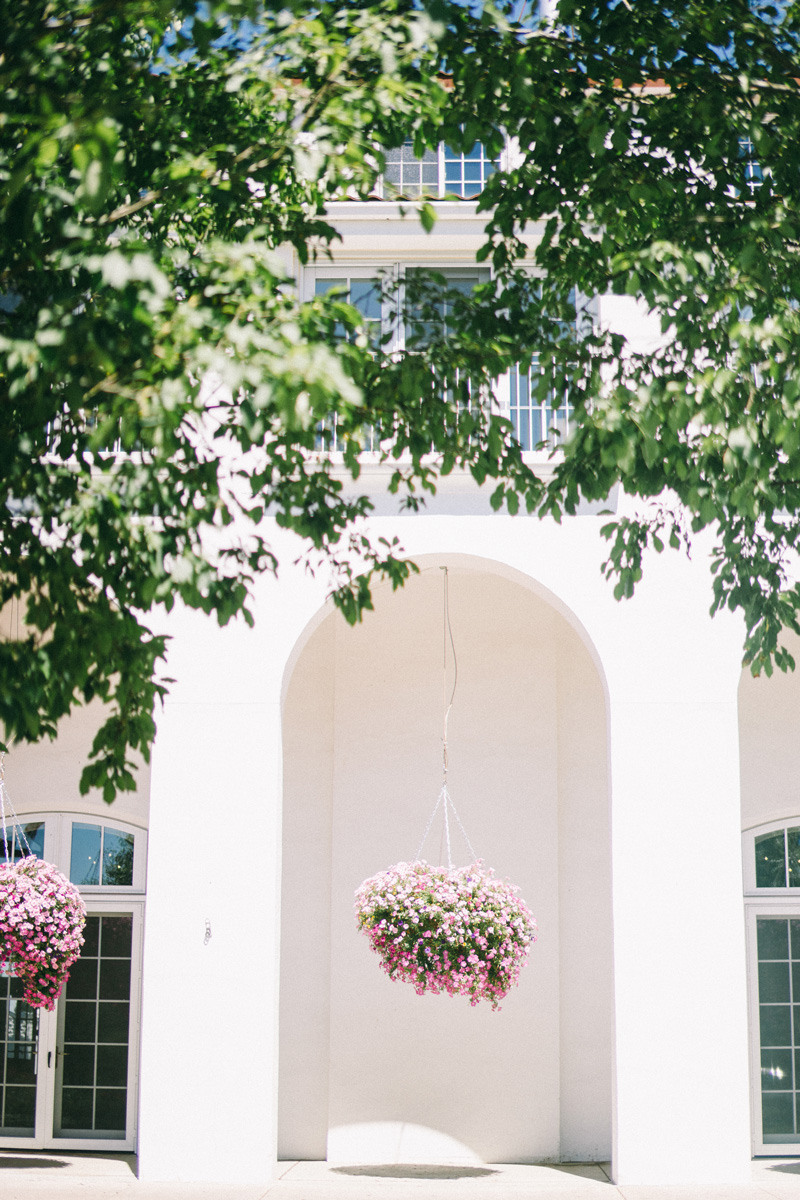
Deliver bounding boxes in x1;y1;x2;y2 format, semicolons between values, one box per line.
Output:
53;913;133;1140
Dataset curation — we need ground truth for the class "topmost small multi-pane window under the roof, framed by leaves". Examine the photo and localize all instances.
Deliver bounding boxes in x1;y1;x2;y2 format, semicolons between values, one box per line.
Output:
384;142;500;199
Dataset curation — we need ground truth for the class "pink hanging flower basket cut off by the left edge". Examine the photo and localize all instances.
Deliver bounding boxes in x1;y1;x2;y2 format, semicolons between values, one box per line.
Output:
0;857;86;1012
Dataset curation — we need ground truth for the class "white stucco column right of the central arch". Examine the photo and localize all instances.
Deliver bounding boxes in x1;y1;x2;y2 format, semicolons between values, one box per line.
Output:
609;628;750;1184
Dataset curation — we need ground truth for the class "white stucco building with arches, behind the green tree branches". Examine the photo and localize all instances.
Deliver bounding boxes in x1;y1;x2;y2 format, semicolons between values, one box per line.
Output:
0;158;800;1183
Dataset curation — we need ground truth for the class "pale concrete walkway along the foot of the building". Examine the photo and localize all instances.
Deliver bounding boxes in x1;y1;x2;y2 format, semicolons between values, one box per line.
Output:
0;1150;800;1200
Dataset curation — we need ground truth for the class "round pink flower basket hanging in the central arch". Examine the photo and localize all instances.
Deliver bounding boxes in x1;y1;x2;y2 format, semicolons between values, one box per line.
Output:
355;862;536;1008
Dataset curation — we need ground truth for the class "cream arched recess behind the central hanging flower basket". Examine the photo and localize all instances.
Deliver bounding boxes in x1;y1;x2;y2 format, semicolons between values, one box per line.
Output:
278;559;613;1162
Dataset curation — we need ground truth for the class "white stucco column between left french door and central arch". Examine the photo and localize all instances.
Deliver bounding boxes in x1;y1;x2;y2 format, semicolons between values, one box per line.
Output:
139;614;281;1183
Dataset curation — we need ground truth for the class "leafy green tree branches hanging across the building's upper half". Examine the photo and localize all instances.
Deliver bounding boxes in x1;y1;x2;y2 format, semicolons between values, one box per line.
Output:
0;0;800;799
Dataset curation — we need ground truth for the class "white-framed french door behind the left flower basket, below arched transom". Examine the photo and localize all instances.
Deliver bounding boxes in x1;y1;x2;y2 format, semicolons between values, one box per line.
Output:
0;901;143;1151
